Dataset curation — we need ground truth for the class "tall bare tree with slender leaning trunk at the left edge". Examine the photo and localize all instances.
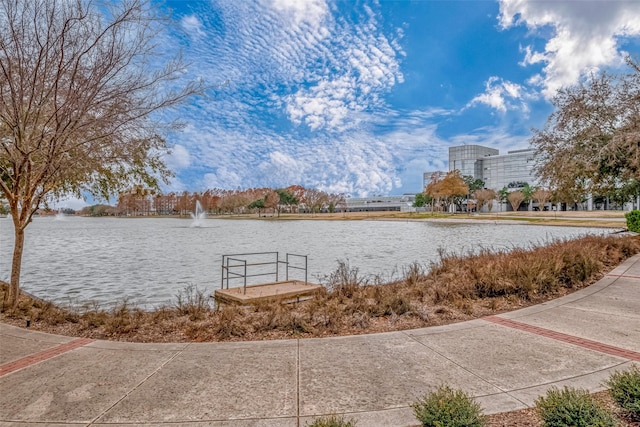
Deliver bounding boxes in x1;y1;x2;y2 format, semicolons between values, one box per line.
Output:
0;0;202;307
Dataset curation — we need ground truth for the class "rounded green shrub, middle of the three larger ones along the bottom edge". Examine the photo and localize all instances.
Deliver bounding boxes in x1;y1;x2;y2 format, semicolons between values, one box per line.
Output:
536;387;618;427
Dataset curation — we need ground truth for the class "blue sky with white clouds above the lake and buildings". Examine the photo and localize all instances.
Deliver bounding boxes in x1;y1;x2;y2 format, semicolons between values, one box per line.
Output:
151;0;640;196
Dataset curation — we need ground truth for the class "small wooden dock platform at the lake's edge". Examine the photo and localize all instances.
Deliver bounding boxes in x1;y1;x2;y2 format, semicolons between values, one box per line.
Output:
213;280;322;305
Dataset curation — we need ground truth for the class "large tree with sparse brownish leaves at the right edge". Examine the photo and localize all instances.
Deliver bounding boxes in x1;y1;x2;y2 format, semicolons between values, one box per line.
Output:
530;58;640;203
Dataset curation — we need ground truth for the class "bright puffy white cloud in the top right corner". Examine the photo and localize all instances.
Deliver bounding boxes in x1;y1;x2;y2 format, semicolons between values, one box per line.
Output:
499;0;640;98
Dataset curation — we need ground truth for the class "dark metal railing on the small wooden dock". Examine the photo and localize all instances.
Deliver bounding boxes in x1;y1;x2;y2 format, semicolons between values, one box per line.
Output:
221;252;308;294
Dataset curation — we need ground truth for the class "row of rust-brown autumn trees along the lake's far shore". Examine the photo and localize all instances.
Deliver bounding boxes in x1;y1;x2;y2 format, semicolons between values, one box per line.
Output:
81;185;347;216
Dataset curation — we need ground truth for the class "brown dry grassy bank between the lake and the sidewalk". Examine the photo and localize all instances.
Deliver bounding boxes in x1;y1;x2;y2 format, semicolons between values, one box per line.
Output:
0;232;640;342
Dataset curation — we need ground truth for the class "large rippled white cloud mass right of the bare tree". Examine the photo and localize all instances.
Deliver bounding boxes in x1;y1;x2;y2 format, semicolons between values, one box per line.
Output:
156;0;412;195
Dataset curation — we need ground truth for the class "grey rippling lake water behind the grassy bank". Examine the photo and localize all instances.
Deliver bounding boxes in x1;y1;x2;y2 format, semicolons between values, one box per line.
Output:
0;217;606;308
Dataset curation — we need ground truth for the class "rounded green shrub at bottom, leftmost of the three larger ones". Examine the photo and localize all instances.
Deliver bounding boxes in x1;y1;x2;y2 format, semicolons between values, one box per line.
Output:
411;386;486;427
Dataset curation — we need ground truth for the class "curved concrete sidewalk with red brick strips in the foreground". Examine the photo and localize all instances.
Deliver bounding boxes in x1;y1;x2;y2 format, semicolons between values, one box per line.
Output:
0;256;640;427
